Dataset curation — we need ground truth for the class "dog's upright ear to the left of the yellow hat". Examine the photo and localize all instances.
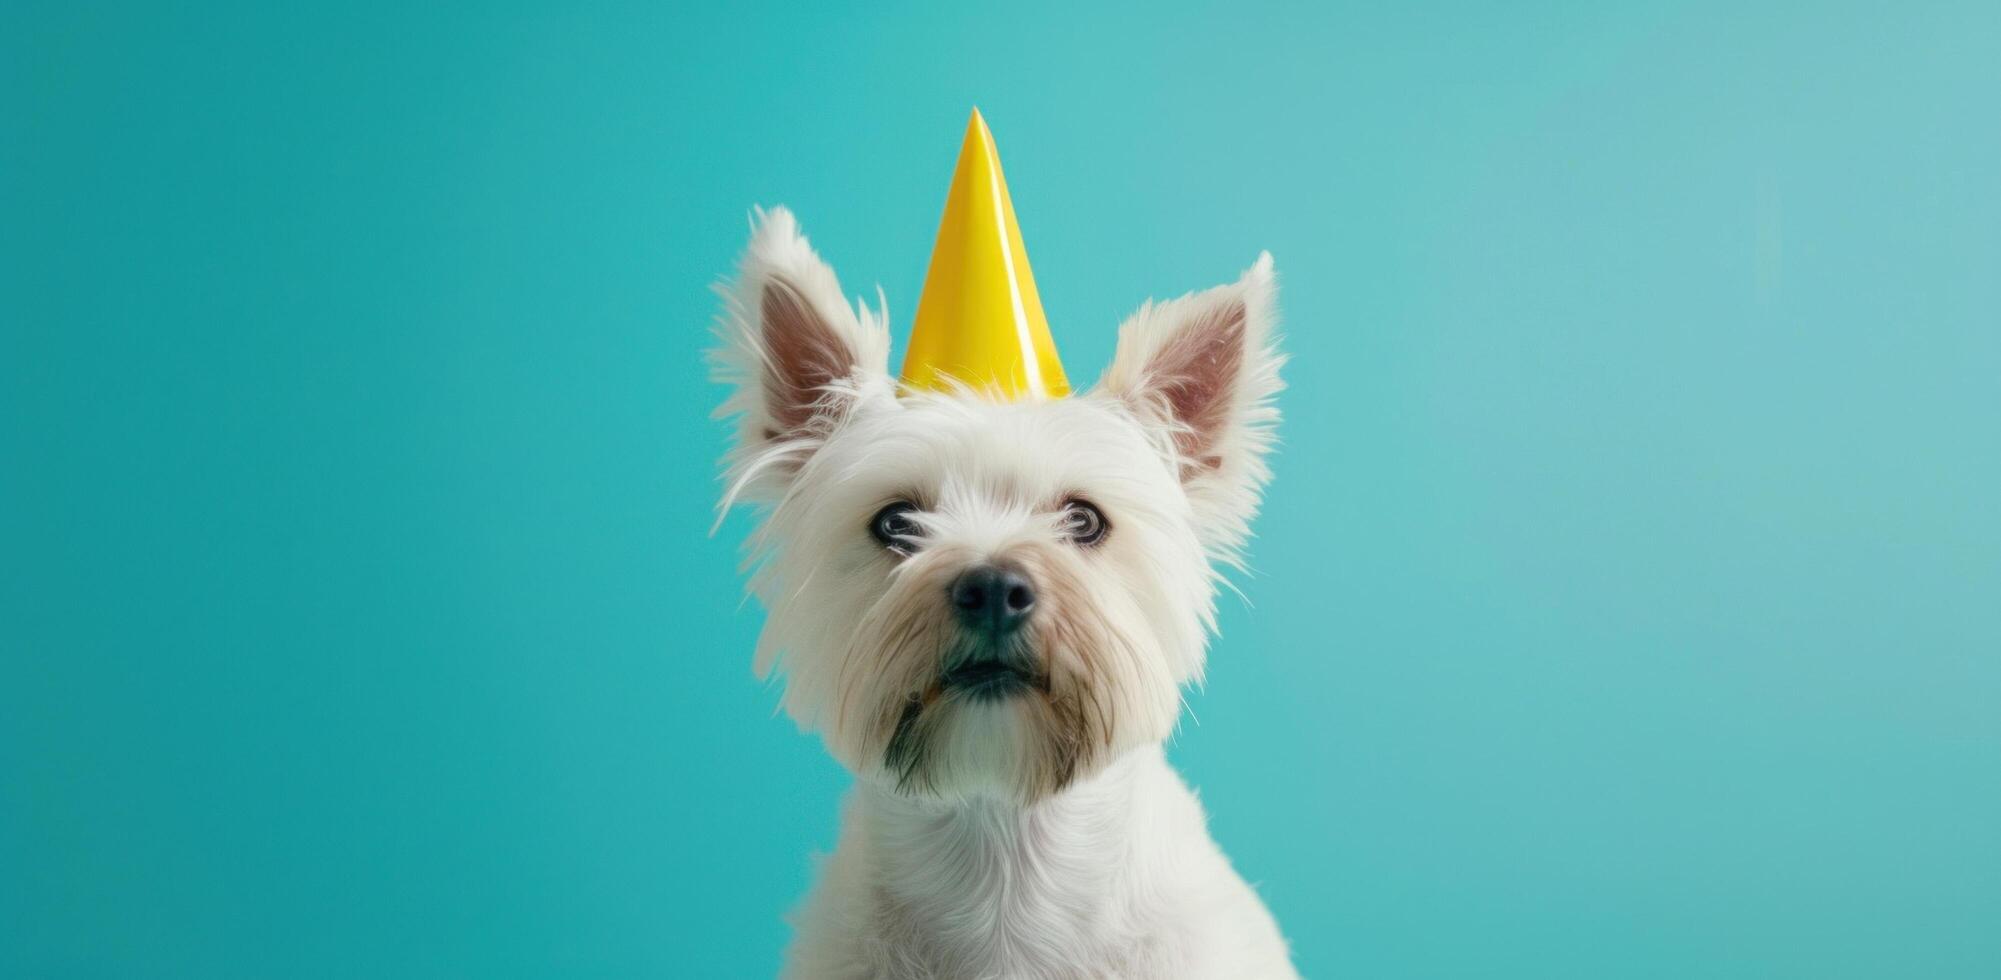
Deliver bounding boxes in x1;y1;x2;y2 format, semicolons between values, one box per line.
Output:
710;208;888;470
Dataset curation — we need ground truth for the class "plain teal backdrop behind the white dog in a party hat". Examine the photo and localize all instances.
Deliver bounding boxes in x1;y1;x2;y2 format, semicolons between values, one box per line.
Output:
0;2;2001;978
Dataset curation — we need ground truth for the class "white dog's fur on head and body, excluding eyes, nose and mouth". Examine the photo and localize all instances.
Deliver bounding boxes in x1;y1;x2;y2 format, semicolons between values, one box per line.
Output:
714;210;1295;980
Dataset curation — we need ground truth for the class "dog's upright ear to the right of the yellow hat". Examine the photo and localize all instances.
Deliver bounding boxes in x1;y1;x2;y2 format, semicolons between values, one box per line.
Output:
1099;252;1285;560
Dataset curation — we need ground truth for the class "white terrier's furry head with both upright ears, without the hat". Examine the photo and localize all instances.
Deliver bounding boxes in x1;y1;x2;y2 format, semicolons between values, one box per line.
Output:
714;210;1283;800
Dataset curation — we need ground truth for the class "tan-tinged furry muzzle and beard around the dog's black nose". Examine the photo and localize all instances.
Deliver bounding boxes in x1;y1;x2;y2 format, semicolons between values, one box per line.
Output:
832;550;1179;802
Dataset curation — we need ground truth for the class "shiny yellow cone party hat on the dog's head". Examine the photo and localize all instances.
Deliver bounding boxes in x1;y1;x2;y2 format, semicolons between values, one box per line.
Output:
902;110;1071;398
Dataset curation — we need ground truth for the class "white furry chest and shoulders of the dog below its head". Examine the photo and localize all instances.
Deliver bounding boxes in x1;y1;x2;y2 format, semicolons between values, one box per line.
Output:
788;750;1295;980
